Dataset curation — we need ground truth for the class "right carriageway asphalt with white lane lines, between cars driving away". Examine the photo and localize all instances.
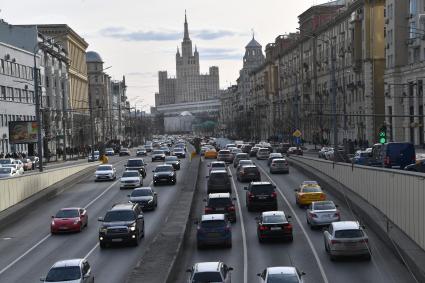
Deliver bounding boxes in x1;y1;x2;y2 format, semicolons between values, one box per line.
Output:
176;160;415;283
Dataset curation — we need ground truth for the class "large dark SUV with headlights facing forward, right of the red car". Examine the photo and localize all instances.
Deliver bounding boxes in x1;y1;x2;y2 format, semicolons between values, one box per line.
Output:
98;203;145;249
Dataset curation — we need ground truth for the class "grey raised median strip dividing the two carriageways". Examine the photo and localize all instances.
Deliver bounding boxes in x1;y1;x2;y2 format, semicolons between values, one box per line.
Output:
125;156;201;283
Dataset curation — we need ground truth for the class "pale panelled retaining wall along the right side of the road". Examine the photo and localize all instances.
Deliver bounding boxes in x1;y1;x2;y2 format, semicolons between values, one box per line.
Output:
291;156;425;250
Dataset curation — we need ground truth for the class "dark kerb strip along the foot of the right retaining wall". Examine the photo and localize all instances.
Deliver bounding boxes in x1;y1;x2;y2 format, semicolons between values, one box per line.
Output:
290;158;425;282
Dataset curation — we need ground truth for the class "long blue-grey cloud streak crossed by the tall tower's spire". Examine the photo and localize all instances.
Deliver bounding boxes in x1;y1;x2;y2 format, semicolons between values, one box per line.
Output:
99;27;245;41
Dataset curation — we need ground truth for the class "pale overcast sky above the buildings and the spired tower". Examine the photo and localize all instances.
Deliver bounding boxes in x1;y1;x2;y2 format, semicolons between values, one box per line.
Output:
0;0;328;110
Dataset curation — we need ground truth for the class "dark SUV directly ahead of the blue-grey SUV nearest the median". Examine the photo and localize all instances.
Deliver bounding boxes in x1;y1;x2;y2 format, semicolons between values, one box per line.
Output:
204;193;236;223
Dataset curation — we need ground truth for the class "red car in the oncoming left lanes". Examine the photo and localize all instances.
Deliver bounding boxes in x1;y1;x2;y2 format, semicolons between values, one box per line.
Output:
50;207;89;234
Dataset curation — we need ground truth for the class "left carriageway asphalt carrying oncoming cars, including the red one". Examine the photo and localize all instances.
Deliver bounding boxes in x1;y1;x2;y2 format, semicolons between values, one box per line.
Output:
0;150;189;283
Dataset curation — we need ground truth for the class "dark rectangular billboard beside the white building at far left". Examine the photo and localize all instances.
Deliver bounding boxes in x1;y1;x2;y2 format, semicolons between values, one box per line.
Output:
9;121;38;144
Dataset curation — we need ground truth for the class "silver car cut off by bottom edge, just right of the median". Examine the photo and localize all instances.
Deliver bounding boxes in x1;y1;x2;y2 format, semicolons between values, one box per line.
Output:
186;261;233;283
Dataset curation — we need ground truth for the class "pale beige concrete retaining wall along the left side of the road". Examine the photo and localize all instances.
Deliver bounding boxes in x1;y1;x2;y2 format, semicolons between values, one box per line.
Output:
0;162;99;212
